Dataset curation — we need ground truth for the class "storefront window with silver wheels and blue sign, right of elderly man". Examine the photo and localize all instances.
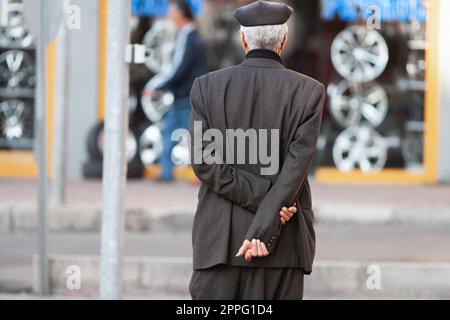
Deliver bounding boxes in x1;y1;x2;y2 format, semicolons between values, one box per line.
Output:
280;0;428;180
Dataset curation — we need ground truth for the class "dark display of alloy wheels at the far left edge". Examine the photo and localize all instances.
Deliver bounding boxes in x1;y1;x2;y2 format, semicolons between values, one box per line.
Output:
0;1;35;150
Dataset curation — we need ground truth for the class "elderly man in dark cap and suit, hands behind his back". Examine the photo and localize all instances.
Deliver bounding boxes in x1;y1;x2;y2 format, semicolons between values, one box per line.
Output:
189;1;325;300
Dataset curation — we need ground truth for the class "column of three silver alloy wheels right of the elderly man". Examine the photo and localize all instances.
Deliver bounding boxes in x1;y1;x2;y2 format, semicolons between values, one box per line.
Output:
328;25;389;172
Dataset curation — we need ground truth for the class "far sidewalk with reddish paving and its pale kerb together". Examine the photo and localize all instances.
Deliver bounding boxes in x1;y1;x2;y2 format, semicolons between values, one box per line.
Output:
0;180;450;232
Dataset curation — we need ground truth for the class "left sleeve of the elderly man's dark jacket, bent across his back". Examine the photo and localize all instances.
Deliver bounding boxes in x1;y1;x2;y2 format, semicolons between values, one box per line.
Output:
189;79;271;213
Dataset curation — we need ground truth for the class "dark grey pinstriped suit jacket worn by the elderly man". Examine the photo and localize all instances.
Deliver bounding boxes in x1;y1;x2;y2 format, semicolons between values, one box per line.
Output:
190;53;325;274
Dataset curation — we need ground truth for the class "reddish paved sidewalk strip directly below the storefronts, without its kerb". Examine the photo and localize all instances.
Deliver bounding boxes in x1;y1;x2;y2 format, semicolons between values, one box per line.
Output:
0;180;450;208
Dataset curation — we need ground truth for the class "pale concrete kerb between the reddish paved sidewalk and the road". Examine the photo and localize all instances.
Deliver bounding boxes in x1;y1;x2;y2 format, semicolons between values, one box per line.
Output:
0;202;450;233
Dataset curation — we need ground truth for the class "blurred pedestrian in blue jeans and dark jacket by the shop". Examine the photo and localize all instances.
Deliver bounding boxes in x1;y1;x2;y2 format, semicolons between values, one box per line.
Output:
143;0;207;182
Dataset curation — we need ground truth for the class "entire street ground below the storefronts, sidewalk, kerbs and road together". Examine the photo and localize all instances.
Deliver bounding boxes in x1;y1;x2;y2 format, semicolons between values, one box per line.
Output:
0;180;450;299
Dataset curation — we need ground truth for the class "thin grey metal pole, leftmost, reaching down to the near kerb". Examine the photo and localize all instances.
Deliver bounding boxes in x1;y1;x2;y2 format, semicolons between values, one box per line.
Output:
36;0;49;296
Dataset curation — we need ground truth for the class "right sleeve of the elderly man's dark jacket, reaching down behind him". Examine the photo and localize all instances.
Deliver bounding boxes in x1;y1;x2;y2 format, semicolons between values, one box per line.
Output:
246;84;325;252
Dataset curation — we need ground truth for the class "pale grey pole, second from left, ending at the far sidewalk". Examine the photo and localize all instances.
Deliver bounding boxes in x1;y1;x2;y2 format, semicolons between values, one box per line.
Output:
51;0;69;207
